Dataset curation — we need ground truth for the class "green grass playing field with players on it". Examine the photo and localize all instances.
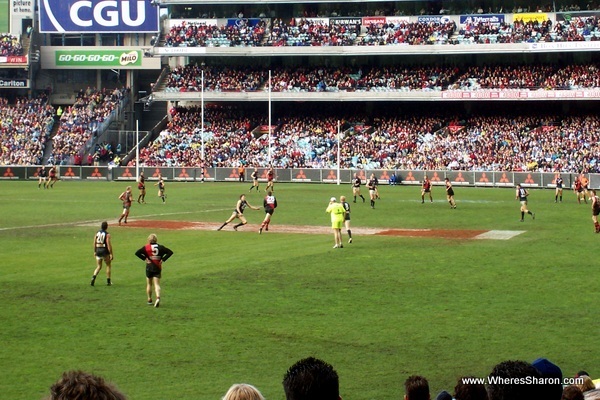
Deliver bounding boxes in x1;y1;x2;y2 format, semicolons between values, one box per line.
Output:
0;181;600;400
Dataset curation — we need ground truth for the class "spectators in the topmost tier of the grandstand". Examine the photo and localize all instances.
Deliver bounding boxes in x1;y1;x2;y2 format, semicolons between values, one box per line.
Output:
165;15;600;47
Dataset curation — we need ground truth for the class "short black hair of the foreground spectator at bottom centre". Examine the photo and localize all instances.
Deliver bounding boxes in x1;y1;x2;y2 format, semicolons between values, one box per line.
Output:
283;357;340;400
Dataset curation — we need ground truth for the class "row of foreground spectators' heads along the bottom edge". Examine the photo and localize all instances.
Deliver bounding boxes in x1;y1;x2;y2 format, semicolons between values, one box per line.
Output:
45;357;600;400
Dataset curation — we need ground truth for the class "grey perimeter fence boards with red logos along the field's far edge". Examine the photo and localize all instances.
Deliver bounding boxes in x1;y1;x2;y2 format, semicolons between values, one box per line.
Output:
10;165;600;189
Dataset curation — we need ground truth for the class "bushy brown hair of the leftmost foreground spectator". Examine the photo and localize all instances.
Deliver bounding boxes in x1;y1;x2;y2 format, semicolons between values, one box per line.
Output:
47;371;127;400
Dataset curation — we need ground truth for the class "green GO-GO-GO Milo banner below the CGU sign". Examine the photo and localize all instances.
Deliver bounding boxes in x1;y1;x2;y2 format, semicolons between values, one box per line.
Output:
54;49;142;68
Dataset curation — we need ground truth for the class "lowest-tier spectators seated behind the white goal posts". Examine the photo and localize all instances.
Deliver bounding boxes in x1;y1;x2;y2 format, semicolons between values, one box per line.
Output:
135;106;600;172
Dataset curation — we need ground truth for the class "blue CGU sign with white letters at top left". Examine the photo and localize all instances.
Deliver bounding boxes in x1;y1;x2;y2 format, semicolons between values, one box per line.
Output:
39;0;159;33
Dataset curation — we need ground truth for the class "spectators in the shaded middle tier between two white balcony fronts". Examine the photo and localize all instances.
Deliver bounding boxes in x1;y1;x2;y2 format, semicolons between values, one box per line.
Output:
166;63;600;92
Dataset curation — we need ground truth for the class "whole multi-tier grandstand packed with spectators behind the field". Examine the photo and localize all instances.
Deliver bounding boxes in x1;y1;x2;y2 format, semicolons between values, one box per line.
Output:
0;2;600;173
